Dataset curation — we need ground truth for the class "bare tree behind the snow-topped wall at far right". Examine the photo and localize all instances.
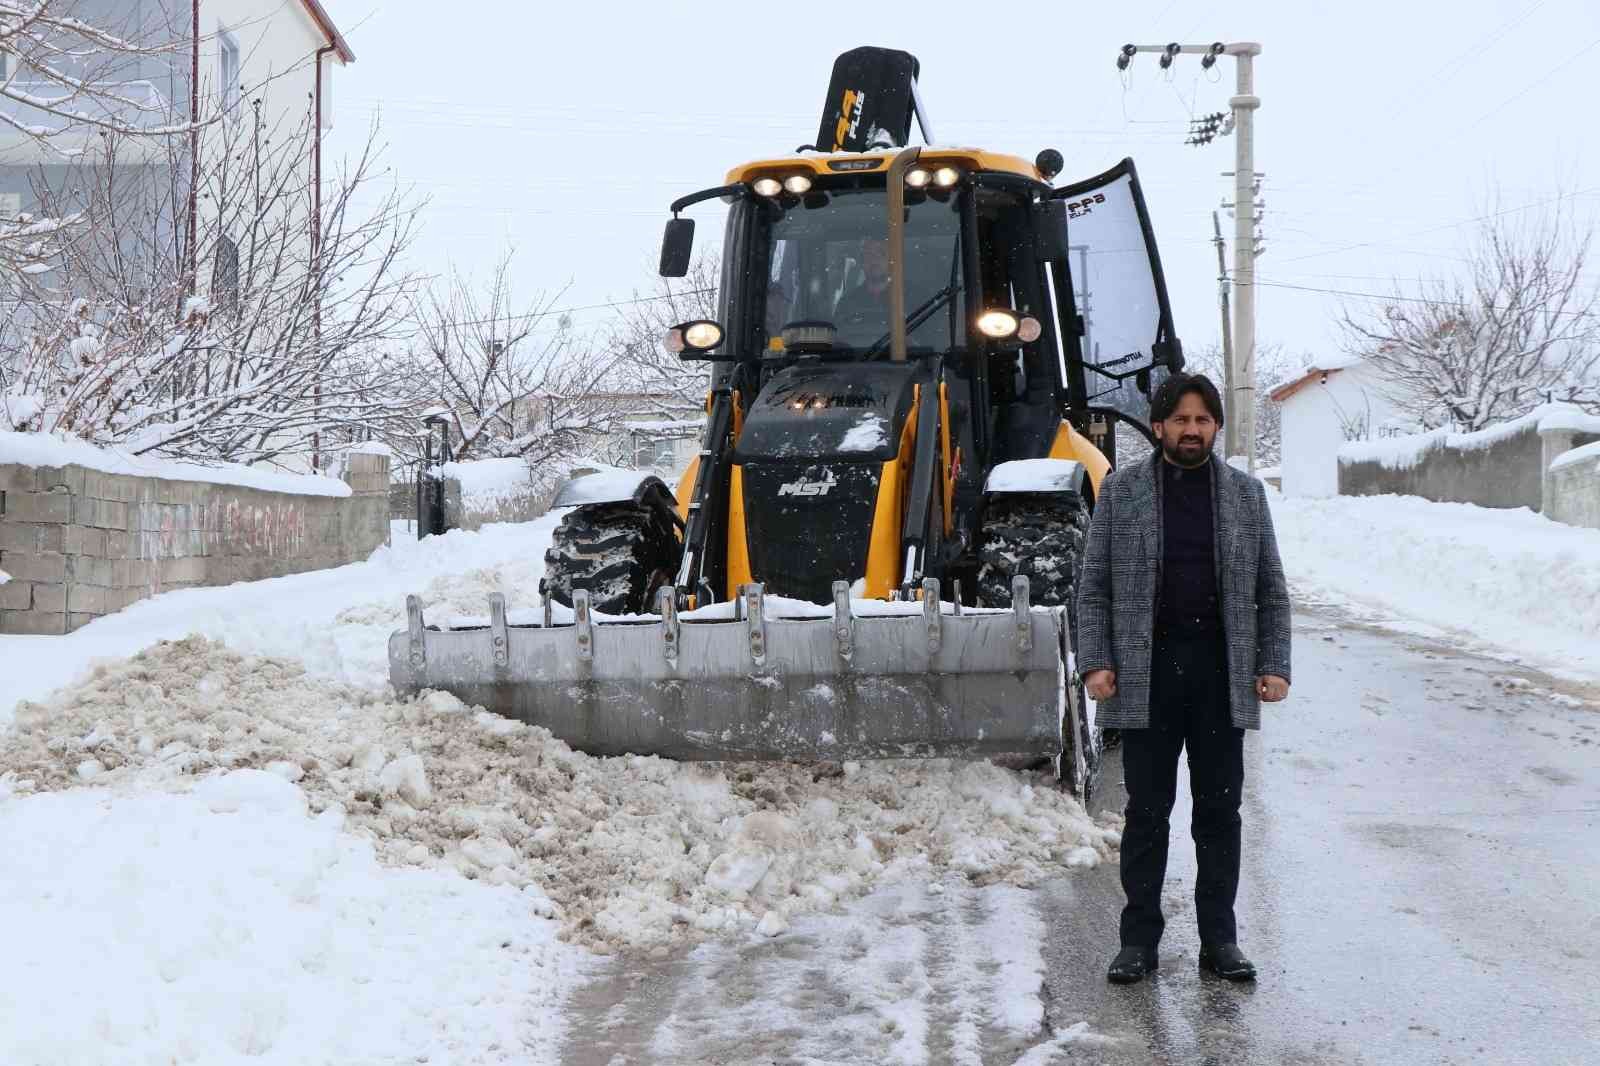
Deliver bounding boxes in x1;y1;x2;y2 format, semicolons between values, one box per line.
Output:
1341;198;1600;431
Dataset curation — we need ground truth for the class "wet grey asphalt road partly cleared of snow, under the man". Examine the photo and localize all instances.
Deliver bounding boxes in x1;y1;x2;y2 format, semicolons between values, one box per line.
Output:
563;611;1600;1066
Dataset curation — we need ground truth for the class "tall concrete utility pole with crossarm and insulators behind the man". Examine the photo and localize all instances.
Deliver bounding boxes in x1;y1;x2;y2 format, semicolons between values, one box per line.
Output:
1117;42;1261;474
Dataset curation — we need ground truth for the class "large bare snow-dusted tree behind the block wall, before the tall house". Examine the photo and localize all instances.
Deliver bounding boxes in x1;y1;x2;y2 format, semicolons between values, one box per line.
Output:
0;114;416;463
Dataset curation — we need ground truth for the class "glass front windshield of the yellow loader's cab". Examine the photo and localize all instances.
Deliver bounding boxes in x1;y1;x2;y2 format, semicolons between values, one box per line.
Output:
762;189;962;354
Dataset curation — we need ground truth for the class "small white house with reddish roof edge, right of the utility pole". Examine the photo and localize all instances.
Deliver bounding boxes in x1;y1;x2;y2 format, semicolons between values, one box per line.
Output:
1267;355;1414;496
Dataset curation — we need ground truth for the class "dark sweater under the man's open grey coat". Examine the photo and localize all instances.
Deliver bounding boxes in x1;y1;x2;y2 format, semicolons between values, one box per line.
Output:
1157;458;1222;637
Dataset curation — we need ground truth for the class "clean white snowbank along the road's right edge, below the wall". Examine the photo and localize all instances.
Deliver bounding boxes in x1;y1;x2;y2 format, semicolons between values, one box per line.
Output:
1267;490;1600;677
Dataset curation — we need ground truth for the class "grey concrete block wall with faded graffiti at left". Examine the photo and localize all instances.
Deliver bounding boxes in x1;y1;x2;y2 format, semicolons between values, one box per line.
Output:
0;455;389;634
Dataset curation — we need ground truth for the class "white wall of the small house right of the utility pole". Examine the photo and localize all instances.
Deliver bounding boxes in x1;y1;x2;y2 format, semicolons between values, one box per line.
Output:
1280;363;1403;496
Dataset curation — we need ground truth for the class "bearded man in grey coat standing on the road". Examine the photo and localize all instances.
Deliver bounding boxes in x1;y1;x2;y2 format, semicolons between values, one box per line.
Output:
1077;373;1290;984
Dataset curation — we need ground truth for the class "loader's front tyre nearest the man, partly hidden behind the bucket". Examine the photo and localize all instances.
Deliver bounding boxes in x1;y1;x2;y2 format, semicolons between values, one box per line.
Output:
978;493;1106;793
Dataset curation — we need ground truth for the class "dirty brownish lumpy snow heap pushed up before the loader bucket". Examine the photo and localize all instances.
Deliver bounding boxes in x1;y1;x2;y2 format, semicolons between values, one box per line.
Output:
0;637;1120;949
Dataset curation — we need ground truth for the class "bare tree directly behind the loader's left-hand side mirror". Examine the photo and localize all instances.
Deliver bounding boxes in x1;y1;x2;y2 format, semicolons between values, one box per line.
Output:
606;251;722;408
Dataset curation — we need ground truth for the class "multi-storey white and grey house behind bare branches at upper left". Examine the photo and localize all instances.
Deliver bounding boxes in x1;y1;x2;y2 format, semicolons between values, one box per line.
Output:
0;0;355;293
